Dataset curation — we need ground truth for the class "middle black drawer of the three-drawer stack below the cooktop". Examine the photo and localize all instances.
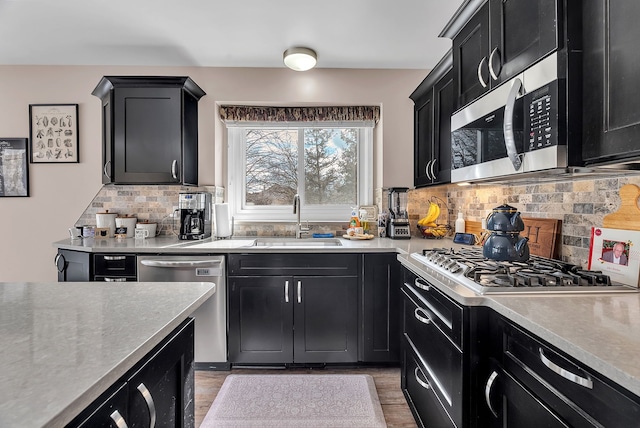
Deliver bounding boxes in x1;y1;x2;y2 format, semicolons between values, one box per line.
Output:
403;290;463;426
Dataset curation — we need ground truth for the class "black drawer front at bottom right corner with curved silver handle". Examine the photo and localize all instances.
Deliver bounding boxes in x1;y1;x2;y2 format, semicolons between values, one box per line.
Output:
500;318;640;427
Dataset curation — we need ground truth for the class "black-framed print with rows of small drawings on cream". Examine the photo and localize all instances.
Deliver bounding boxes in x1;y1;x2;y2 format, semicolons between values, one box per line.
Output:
29;104;79;163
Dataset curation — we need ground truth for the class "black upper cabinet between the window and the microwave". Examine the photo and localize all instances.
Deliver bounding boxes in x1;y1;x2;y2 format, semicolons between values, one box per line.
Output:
410;52;454;187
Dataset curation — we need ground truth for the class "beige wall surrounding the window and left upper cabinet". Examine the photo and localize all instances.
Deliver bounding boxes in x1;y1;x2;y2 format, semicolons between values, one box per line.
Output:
0;66;427;281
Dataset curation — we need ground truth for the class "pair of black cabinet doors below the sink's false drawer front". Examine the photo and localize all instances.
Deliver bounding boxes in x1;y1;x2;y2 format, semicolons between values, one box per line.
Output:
228;276;358;364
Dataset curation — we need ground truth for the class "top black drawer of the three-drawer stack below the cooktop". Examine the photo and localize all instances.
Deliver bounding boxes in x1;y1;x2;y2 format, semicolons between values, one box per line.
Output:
403;269;464;350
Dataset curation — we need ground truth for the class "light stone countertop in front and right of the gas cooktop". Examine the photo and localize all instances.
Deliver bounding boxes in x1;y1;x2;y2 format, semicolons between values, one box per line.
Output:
398;255;640;397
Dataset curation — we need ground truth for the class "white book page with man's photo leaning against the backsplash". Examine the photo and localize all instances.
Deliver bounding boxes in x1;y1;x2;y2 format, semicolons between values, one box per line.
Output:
588;227;640;287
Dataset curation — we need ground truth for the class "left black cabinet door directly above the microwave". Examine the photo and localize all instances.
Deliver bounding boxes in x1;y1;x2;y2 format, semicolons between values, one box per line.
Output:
453;3;491;108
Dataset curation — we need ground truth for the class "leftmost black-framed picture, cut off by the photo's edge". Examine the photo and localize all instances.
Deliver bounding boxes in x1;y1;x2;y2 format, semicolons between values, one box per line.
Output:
0;138;29;197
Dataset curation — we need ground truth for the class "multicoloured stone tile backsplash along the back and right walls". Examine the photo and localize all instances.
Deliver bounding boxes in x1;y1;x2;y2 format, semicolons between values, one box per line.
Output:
76;176;640;266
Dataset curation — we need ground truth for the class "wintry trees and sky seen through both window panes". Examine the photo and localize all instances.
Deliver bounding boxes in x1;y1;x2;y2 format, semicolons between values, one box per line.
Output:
245;128;358;205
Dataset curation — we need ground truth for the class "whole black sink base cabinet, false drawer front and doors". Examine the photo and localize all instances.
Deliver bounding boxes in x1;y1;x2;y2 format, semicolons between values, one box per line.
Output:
228;254;359;364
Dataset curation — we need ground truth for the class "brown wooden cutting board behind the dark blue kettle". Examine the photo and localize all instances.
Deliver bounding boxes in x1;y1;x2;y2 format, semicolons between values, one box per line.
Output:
465;217;562;259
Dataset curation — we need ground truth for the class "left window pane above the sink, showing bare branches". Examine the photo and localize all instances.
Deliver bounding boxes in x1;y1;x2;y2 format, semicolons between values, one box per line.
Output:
245;129;298;205
